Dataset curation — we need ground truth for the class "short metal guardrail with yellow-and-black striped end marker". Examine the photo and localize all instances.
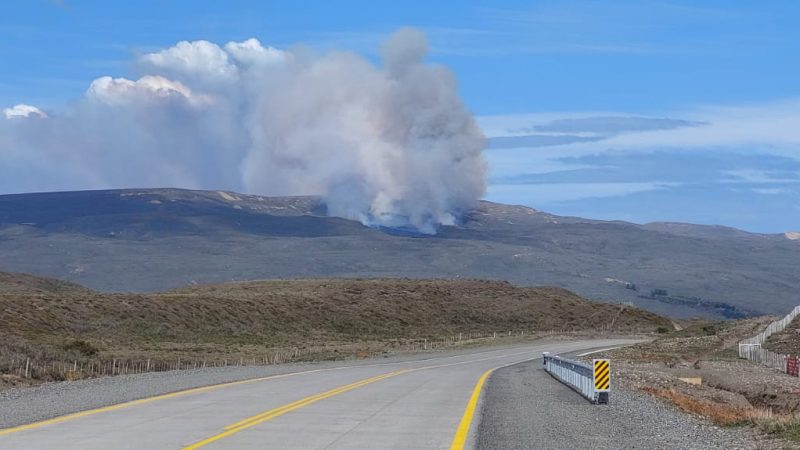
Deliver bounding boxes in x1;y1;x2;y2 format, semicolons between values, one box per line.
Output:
542;352;611;404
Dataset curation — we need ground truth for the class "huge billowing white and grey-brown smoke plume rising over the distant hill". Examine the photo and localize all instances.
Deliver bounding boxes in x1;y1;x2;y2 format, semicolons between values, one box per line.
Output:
0;29;486;233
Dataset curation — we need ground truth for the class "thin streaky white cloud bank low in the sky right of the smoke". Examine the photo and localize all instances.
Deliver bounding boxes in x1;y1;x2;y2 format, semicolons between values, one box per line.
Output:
479;103;800;229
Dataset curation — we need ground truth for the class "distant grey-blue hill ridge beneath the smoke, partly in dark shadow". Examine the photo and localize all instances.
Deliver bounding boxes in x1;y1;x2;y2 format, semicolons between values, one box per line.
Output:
0;189;800;317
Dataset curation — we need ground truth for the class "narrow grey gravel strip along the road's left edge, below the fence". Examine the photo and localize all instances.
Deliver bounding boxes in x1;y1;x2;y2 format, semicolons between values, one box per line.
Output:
0;340;560;428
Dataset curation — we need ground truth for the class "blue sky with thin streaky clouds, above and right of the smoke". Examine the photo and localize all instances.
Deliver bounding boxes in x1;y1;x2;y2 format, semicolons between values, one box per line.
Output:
0;0;800;232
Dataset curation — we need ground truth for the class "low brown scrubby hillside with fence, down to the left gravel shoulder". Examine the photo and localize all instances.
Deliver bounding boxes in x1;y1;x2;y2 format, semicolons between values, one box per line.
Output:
0;275;672;379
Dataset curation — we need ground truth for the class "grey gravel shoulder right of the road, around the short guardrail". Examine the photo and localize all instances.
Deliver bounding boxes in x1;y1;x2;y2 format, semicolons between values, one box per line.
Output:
476;360;782;450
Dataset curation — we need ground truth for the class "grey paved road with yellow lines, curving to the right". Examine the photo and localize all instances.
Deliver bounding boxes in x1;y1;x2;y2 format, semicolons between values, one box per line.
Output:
0;340;630;450
